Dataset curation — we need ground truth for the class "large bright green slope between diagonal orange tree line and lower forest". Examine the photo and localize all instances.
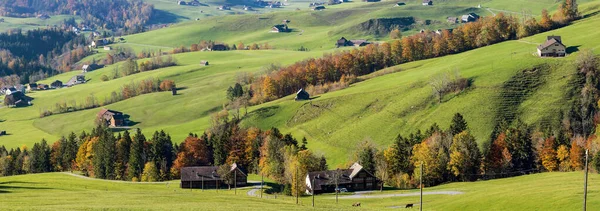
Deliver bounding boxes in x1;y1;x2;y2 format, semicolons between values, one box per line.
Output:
245;3;600;163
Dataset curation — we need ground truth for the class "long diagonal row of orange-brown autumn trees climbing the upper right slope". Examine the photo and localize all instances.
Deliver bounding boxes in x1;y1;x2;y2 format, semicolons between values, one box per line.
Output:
250;3;578;104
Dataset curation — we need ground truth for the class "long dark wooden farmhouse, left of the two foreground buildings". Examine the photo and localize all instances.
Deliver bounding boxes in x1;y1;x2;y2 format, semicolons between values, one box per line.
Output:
179;163;248;189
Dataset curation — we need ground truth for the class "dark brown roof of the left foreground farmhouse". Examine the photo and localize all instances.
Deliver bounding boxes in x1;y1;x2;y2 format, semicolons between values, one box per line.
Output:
181;163;247;181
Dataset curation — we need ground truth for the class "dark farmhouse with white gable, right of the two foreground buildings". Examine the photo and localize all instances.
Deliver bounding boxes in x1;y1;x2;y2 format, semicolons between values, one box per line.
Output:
305;163;379;194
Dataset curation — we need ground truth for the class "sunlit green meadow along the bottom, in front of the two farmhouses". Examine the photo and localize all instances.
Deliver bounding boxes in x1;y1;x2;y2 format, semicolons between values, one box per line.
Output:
0;172;600;210
